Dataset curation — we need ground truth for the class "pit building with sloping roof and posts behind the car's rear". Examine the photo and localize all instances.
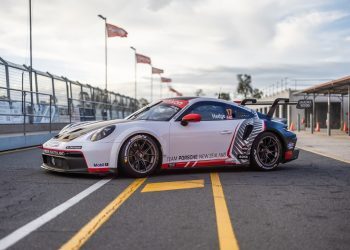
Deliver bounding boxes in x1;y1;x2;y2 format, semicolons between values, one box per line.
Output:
254;76;350;136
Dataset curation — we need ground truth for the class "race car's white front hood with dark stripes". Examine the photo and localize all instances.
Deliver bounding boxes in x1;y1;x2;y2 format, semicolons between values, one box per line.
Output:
54;119;132;142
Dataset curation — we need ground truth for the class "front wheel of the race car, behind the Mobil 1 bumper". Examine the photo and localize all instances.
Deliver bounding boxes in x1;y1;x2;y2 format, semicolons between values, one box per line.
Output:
119;134;161;178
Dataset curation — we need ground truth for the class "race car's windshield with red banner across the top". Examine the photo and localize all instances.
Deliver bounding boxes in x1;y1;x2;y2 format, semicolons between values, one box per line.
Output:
126;100;188;121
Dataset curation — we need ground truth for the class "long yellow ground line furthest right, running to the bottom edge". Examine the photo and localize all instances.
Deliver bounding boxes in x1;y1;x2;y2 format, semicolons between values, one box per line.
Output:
210;173;239;250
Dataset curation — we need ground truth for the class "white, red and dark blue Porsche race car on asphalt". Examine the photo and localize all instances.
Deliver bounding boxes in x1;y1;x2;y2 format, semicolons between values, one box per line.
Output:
42;97;299;177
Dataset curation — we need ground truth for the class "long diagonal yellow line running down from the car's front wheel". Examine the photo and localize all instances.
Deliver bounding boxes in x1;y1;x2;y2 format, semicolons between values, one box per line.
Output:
60;178;146;250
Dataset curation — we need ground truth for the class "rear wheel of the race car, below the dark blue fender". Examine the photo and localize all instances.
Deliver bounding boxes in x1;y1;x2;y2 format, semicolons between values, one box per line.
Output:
250;132;282;171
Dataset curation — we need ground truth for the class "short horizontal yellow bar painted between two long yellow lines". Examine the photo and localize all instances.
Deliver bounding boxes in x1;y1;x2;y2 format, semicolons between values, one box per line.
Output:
141;180;204;193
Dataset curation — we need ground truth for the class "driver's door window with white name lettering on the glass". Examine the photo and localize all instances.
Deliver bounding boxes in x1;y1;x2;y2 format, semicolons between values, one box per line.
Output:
185;102;226;121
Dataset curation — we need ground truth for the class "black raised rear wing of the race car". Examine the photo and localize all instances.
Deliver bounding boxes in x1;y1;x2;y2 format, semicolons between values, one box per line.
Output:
240;98;313;118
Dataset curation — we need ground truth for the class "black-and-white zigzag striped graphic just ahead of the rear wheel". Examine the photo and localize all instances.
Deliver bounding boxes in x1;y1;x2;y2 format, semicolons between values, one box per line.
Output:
231;118;264;164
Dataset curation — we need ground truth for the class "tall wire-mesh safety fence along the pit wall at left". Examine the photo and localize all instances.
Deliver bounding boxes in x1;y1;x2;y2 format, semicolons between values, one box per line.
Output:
0;57;138;127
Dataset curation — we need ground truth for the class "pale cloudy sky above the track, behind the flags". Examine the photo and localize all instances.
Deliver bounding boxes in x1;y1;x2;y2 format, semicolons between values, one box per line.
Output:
0;0;350;100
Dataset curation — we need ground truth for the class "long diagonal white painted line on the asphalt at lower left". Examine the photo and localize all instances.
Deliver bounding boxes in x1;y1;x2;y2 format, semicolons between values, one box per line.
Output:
0;179;111;250
